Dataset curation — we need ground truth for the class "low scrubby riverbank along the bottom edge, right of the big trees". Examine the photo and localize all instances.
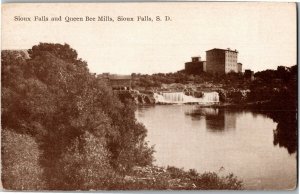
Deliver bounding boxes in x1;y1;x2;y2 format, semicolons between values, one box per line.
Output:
110;166;243;190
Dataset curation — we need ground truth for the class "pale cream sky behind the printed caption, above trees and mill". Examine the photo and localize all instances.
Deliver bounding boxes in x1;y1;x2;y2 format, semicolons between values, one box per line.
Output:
2;2;297;74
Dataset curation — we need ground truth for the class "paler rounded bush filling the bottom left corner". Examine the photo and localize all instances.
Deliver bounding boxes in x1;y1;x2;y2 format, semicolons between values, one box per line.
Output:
1;129;45;190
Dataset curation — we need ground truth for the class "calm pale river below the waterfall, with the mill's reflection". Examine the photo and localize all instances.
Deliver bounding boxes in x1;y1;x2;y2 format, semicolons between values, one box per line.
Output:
136;105;297;190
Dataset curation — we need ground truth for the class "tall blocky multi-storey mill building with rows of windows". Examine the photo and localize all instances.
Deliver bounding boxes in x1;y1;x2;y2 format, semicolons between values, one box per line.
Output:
206;48;242;74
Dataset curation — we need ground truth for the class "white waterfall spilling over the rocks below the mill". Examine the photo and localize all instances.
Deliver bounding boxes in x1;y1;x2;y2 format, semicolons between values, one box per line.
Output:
154;92;219;104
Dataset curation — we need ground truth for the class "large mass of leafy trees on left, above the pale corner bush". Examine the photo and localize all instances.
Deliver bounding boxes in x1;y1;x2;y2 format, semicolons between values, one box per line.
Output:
1;43;153;190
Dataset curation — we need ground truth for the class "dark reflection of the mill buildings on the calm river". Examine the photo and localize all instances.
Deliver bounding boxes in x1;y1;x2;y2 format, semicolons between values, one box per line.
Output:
186;108;236;132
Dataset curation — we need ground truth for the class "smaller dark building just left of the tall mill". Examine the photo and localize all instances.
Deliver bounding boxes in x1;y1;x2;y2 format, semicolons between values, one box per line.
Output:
185;57;206;75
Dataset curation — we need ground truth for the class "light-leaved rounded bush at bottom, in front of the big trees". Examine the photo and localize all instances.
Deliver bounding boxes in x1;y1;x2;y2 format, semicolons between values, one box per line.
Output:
59;132;114;190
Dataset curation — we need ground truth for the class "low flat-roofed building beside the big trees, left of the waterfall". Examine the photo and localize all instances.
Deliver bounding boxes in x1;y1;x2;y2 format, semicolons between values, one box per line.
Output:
99;73;131;90
